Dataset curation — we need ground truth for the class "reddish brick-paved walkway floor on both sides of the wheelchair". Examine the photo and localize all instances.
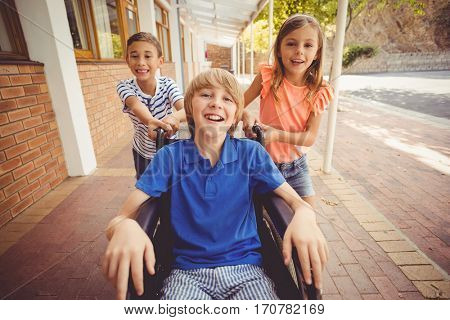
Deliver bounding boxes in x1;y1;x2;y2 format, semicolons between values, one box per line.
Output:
0;95;450;299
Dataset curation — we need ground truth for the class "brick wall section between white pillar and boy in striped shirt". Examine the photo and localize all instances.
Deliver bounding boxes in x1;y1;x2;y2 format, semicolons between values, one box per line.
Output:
78;62;132;156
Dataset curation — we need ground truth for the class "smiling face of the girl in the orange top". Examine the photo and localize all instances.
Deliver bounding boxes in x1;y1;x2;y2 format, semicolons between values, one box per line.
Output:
278;24;319;82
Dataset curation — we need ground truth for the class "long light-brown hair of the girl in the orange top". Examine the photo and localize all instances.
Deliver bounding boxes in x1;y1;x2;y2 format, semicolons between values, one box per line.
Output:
270;14;324;101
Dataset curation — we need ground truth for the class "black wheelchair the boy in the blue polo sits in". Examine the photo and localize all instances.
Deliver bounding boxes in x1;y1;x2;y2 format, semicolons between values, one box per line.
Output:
127;126;321;300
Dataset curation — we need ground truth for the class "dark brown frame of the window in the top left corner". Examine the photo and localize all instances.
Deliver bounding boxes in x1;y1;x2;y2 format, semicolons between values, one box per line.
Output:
0;0;30;62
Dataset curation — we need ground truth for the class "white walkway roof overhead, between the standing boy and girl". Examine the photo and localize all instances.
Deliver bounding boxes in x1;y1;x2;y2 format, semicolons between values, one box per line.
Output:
179;0;268;47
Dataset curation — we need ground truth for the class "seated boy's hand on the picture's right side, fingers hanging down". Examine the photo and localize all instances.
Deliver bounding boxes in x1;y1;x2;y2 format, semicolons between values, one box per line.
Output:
283;209;328;289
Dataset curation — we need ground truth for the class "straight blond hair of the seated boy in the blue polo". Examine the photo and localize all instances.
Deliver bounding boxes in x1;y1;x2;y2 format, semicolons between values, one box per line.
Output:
184;68;244;137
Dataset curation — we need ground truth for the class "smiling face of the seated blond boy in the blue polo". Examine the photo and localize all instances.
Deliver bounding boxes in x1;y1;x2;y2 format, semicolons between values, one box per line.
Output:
192;86;237;137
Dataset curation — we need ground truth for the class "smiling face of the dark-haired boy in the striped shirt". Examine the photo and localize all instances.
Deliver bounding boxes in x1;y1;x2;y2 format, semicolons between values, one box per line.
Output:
127;41;163;82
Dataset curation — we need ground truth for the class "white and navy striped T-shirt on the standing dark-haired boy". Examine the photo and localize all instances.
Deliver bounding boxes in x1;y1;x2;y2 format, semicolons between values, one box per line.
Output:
117;77;183;159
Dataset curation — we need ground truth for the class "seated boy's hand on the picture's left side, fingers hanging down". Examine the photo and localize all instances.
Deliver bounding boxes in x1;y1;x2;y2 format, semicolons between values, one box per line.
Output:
102;219;155;300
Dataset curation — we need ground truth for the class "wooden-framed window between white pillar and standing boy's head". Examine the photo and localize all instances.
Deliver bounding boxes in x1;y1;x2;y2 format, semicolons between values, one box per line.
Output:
64;0;139;59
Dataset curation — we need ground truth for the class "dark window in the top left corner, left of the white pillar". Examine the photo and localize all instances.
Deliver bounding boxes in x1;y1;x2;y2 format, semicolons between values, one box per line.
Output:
0;0;28;60
